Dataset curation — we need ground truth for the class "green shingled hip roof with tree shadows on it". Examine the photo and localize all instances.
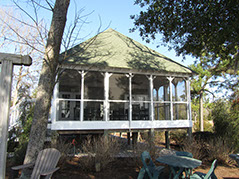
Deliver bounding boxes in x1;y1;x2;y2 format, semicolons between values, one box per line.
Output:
64;29;192;73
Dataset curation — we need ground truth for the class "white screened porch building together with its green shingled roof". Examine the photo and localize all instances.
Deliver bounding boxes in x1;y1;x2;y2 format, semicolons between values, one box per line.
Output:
51;29;193;141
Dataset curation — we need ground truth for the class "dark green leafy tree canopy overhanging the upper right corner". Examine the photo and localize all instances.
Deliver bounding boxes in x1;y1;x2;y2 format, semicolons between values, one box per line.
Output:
131;0;239;74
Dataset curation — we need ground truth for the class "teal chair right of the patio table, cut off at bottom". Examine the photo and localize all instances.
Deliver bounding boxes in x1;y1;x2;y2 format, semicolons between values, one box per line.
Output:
190;160;217;179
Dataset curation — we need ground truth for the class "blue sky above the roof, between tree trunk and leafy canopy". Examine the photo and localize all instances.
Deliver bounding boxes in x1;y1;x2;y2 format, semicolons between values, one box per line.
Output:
69;0;194;66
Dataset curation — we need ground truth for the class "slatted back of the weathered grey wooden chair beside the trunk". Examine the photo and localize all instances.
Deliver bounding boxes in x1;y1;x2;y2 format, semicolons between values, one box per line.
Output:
31;148;61;179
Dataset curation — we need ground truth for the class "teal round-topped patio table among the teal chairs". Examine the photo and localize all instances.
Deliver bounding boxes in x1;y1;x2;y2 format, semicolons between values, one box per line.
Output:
156;155;202;179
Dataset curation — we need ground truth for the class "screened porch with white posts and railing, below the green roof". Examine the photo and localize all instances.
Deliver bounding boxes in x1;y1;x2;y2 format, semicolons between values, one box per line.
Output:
51;69;192;130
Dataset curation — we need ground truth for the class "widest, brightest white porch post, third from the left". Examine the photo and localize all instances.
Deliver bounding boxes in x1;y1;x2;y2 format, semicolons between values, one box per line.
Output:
104;72;112;121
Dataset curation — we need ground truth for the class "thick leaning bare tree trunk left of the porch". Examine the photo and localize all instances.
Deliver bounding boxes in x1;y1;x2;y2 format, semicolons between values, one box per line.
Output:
24;0;70;169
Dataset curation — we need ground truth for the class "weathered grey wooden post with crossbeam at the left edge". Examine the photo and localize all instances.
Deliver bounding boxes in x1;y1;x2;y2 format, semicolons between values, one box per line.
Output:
0;53;32;179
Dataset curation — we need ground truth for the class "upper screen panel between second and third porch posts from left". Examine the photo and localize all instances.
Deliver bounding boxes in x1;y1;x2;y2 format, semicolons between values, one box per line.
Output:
84;72;104;100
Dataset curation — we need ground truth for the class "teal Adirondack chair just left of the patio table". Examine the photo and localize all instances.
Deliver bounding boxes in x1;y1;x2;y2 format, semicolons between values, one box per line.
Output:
138;151;164;179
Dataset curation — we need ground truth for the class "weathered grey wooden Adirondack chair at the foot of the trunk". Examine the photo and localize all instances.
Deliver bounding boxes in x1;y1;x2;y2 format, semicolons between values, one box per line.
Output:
12;148;61;179
